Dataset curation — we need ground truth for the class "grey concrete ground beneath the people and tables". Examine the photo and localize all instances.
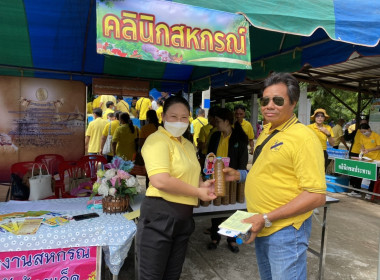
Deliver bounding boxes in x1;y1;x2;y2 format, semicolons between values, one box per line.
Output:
119;193;380;280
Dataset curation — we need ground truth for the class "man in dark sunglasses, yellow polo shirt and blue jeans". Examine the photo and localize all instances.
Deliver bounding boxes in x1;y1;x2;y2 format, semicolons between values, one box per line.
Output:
224;73;326;279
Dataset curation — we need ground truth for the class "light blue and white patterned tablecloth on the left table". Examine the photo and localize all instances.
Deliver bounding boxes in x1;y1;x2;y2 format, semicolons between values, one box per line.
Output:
0;198;136;275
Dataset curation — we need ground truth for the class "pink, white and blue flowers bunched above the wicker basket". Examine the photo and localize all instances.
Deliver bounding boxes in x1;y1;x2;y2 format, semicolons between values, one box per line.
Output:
90;156;141;201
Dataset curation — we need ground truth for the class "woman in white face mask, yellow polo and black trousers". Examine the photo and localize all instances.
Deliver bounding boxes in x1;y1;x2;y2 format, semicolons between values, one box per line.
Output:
136;96;216;280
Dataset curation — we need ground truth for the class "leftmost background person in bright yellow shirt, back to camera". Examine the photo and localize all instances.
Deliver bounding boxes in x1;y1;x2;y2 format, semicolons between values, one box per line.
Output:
85;108;107;155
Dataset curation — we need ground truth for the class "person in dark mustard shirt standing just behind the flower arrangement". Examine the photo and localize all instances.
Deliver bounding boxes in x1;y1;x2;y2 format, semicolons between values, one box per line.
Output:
112;113;139;160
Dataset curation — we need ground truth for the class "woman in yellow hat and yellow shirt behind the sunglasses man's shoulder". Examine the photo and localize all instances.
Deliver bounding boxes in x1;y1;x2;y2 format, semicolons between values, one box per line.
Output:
308;109;334;170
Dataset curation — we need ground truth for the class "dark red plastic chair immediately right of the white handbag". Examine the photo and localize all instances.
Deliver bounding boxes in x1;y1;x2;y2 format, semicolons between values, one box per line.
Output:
55;161;84;198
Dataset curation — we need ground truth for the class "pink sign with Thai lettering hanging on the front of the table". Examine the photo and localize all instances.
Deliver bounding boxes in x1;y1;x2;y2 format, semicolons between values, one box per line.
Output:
0;246;101;280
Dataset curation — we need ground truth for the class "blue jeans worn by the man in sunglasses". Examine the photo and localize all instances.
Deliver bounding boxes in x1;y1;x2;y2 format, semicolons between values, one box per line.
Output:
255;217;311;280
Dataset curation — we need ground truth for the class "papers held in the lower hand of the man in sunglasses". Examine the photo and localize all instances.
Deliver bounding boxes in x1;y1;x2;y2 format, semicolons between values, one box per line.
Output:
218;210;257;237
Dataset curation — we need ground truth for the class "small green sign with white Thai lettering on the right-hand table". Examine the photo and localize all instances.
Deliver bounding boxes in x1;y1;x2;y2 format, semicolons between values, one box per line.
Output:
334;158;377;181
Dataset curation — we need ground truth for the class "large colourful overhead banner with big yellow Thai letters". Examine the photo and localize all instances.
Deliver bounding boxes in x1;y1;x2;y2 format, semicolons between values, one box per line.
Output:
96;0;252;69
